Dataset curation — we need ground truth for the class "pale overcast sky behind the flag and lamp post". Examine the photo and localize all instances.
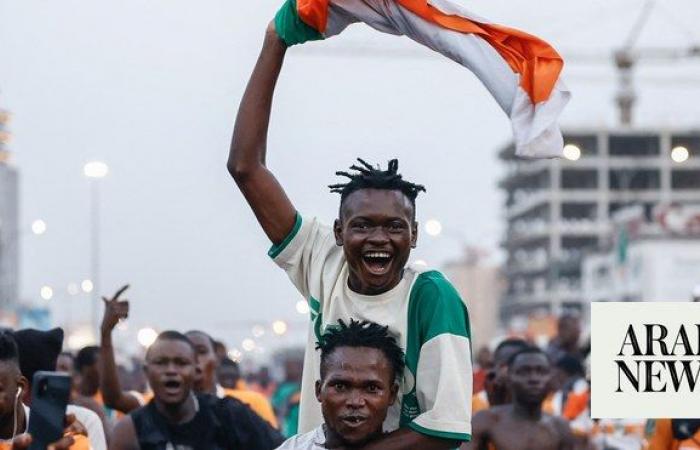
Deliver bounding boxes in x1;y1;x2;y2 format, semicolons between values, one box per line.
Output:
0;0;700;354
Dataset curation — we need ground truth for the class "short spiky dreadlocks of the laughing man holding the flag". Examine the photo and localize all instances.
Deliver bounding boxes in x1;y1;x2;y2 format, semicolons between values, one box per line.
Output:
328;158;425;206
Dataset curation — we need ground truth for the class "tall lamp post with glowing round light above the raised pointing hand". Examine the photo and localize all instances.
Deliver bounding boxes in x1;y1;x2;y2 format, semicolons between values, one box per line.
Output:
83;161;109;336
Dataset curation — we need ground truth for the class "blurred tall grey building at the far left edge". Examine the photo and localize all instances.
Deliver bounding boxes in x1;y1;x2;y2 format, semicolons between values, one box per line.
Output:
0;109;20;313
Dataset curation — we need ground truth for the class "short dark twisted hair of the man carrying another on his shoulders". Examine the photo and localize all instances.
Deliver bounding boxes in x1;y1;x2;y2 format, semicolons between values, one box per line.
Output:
316;319;406;381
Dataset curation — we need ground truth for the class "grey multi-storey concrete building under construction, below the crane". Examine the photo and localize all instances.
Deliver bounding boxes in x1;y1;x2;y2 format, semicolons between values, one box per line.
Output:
499;129;700;320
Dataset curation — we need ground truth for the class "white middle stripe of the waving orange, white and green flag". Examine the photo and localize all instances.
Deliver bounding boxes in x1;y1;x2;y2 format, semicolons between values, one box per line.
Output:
325;0;571;158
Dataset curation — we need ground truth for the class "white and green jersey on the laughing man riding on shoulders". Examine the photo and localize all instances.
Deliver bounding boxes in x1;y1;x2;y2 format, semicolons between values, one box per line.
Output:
269;214;472;441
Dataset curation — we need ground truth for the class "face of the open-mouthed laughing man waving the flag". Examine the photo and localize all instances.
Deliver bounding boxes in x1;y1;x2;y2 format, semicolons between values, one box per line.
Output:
334;189;418;295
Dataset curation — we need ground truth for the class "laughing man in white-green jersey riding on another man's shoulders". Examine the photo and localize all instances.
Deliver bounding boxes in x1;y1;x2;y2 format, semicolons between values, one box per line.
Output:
228;14;472;450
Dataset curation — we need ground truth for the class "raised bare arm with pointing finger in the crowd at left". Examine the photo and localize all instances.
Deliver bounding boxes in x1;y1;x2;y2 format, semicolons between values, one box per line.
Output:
99;285;141;414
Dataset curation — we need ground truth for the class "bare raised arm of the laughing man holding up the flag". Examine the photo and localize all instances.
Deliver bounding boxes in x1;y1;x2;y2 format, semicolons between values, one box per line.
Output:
227;23;296;244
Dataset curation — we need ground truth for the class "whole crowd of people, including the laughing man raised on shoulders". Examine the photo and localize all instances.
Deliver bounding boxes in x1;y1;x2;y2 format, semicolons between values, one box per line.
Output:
0;9;700;450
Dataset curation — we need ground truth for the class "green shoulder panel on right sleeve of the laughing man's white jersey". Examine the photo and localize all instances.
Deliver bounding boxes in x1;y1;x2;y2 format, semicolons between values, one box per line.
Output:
409;271;471;346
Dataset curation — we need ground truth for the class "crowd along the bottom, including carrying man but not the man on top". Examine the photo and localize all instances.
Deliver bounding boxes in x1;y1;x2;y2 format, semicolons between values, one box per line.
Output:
0;306;700;450
